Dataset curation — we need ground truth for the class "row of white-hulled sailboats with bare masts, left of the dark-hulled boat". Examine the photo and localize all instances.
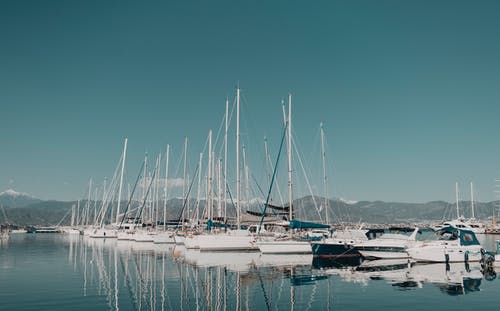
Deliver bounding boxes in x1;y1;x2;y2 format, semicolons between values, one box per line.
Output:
75;88;336;254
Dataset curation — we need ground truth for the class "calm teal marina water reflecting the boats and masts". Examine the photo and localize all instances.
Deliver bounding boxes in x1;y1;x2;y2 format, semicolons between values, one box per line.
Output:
0;234;500;311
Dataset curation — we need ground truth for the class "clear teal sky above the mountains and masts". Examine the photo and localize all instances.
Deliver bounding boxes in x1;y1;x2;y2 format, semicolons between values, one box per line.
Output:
0;0;500;202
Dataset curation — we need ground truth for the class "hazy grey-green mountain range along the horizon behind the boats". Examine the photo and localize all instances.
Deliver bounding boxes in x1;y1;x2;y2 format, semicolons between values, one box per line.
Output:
0;190;500;225
